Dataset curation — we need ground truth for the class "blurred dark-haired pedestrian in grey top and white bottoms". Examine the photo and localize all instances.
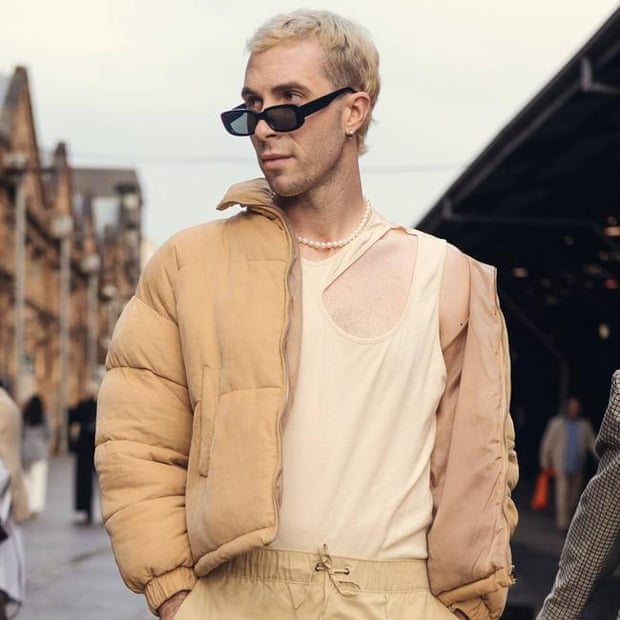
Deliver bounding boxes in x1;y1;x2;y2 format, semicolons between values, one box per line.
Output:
22;394;50;516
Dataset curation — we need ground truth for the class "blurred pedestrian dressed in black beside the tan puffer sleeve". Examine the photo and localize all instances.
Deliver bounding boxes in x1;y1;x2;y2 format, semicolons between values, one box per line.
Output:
70;382;97;524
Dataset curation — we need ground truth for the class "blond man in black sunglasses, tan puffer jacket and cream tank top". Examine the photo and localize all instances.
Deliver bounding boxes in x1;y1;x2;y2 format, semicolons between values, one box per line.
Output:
96;11;517;620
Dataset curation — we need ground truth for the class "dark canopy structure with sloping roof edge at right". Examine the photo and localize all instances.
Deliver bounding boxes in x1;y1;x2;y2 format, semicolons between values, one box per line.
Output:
417;10;620;473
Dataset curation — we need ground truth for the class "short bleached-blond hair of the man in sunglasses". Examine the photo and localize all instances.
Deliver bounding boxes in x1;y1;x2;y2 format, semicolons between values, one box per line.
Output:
247;9;381;155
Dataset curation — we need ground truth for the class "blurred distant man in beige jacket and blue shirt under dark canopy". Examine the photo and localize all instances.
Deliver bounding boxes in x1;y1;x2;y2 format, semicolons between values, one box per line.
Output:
540;396;596;533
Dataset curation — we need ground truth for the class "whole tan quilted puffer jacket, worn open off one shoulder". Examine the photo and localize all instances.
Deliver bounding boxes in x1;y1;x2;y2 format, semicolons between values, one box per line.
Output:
96;180;517;619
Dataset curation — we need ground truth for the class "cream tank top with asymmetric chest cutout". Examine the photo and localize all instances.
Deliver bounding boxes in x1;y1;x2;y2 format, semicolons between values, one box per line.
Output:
271;213;446;560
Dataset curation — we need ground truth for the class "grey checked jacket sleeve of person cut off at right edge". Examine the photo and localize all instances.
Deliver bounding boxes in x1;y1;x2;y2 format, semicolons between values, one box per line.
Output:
538;370;620;620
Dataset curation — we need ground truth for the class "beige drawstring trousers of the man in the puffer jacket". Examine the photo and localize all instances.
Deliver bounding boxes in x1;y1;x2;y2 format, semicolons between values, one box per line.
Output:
174;545;455;620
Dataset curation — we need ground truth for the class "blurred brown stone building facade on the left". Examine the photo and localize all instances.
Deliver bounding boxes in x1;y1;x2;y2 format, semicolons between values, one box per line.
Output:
0;67;142;451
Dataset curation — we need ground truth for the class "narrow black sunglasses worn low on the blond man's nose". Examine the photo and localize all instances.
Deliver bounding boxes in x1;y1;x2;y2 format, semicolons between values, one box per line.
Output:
220;86;355;136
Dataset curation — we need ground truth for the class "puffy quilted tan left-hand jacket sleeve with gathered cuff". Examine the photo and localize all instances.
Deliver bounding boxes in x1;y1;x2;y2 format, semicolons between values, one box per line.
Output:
95;240;196;611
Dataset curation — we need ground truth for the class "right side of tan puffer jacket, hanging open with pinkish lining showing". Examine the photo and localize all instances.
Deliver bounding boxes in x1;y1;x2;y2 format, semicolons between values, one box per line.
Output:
428;260;519;620
